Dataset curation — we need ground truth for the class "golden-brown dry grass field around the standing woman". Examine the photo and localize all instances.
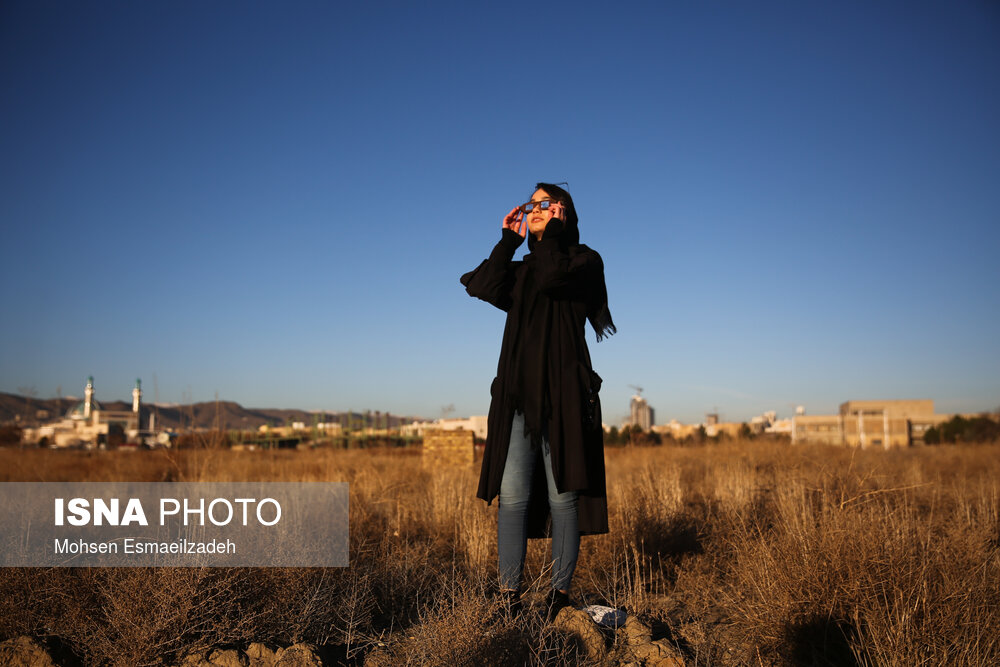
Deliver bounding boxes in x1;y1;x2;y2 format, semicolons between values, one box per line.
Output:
0;442;1000;666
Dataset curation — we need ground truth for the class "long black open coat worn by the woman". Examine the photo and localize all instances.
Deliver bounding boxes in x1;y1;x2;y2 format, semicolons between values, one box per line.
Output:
461;219;615;537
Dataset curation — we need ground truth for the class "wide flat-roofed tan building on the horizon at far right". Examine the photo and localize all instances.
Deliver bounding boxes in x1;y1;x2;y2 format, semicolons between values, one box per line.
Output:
792;399;951;449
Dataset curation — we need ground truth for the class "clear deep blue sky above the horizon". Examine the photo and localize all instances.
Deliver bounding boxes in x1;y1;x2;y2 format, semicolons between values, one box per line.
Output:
0;0;1000;422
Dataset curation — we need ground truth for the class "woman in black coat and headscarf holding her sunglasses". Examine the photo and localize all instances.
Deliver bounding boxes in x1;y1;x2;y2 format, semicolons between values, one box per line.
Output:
462;183;615;618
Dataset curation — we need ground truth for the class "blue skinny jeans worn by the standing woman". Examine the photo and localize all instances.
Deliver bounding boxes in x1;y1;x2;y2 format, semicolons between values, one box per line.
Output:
497;412;580;591
